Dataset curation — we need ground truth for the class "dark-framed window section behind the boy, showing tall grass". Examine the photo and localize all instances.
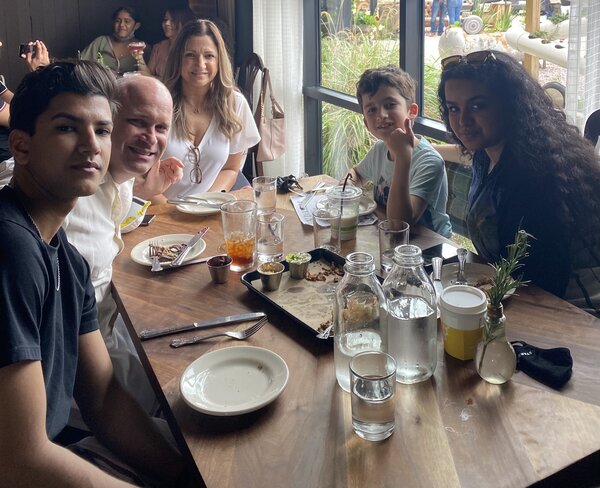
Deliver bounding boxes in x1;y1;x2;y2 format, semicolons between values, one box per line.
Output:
304;0;444;177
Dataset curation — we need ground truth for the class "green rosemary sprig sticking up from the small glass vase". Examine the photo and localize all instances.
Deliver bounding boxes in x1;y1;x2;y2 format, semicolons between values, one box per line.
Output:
488;229;534;306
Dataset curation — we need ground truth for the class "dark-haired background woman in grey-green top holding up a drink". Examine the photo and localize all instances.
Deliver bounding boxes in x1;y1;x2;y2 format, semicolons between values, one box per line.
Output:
81;7;149;75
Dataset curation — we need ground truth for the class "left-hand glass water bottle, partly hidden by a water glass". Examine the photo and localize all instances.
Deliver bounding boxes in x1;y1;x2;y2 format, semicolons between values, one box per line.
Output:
333;252;387;392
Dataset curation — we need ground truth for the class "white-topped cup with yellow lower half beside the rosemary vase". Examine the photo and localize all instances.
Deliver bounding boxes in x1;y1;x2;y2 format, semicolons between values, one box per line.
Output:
439;285;487;360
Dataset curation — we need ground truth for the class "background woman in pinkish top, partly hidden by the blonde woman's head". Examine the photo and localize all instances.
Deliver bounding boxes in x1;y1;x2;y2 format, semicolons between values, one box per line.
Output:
138;7;195;80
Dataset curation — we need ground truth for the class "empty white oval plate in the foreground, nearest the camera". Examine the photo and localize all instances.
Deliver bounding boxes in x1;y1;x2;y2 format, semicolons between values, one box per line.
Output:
179;346;289;416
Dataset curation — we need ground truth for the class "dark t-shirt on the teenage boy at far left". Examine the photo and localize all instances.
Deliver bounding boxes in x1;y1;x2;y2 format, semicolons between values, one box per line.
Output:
0;187;98;439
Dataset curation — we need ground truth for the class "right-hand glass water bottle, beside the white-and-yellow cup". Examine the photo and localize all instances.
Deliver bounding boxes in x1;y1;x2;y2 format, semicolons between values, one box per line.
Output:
383;245;437;384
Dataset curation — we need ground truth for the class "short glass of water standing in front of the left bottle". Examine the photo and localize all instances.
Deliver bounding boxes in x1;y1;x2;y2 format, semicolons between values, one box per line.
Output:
350;351;396;441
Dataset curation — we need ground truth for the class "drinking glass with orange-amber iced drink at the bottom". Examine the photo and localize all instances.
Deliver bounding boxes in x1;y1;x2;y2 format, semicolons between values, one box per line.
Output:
221;200;256;271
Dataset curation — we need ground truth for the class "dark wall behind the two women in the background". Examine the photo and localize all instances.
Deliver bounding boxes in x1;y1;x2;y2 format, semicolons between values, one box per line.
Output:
0;0;239;90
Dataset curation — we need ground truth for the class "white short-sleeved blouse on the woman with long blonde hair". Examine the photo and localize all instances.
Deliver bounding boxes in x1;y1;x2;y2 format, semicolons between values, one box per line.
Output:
163;92;260;198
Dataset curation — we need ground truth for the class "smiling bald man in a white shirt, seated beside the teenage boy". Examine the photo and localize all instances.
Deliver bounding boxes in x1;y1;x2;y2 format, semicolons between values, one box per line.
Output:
63;76;183;413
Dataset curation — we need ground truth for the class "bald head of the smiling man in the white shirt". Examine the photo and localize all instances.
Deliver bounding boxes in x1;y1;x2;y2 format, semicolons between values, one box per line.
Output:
109;76;173;183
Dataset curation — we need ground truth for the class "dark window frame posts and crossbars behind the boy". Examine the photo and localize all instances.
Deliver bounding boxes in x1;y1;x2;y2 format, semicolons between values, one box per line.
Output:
302;0;447;175
